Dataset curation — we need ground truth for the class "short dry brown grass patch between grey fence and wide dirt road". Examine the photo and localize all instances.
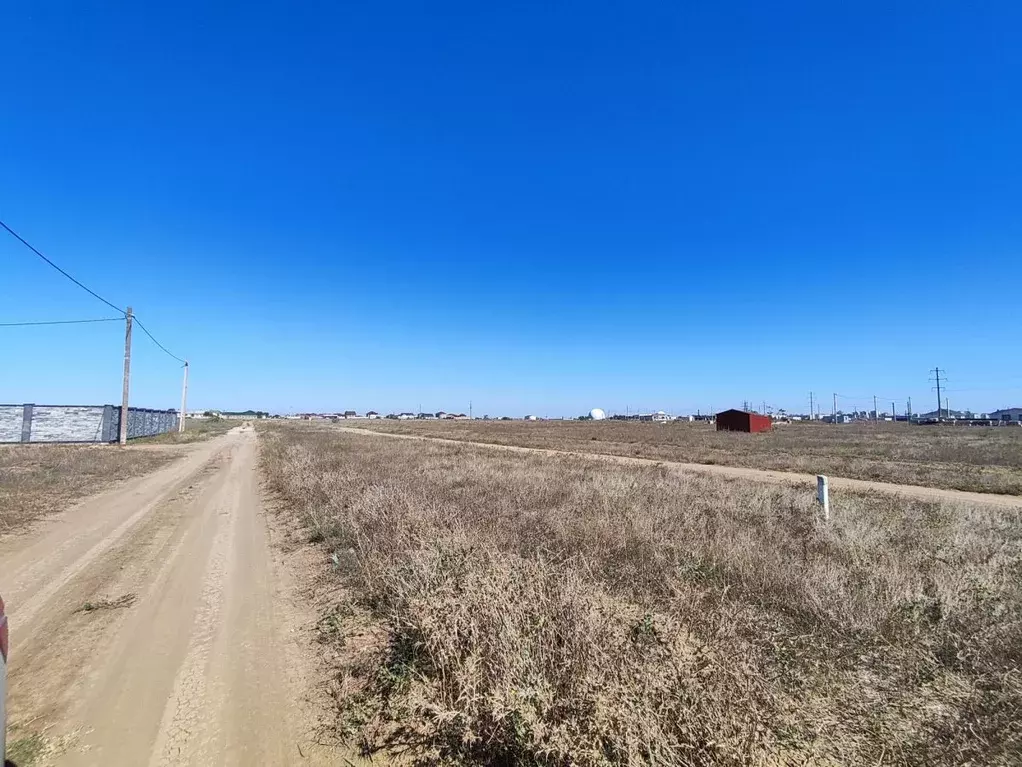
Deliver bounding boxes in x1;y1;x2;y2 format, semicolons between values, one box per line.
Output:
0;445;178;535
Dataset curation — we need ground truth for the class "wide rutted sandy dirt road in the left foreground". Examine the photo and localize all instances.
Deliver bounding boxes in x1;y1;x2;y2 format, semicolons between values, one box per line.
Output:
0;426;335;767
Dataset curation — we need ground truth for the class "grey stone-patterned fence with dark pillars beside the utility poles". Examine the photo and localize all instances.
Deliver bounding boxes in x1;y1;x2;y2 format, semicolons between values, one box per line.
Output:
0;405;178;443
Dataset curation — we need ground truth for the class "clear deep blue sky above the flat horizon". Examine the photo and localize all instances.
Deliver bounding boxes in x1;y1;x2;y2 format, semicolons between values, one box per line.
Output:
0;0;1022;415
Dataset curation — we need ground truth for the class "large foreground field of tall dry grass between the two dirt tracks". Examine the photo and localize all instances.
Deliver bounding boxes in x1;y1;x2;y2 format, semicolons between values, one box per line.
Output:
262;424;1022;767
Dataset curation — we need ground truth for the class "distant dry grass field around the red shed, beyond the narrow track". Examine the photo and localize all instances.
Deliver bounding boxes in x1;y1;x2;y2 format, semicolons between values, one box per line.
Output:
344;420;1022;495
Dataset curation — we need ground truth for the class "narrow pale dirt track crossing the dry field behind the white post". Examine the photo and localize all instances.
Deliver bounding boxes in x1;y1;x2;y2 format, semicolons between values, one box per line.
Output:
340;426;1022;508
